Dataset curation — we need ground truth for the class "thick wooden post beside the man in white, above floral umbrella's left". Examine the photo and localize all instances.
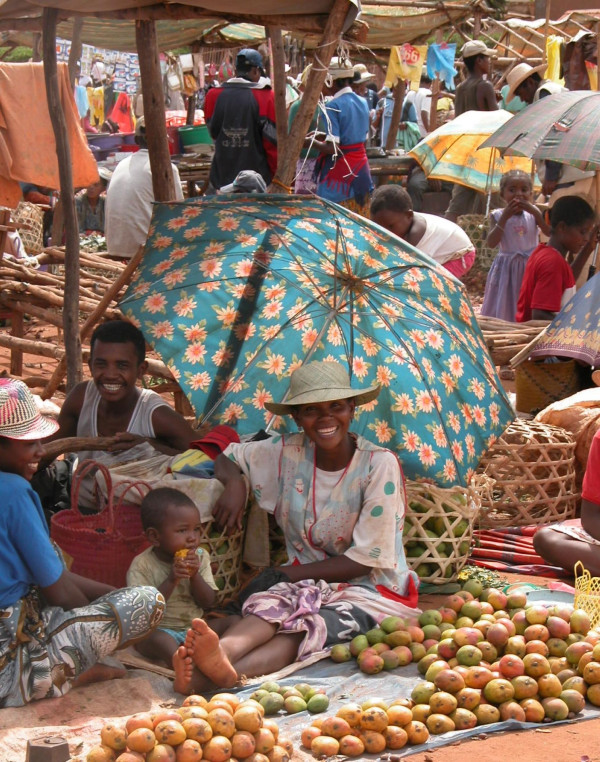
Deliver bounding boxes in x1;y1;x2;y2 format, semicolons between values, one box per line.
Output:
135;21;175;201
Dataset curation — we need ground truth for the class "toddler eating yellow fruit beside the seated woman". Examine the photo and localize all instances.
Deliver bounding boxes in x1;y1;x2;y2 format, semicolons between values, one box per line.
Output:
127;487;217;666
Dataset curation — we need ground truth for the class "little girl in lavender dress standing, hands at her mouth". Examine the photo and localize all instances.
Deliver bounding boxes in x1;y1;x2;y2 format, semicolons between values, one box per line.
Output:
481;169;550;323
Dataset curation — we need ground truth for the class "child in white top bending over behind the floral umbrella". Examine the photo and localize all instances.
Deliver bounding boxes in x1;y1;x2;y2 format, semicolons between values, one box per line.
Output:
371;185;476;278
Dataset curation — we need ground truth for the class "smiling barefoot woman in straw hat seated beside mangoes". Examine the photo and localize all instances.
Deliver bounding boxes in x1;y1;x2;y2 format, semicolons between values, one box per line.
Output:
173;362;416;693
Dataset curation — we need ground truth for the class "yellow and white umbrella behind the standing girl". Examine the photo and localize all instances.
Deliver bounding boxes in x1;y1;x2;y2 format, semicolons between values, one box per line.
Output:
409;109;531;193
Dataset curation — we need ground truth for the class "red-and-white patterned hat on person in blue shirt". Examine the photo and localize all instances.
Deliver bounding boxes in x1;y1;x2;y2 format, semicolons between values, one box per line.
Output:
0;378;58;439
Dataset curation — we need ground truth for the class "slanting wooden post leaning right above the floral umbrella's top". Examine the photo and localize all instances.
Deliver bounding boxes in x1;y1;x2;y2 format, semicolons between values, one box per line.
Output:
269;0;350;193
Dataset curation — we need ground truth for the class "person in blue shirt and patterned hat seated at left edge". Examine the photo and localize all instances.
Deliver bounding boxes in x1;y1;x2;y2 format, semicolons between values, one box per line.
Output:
0;378;164;707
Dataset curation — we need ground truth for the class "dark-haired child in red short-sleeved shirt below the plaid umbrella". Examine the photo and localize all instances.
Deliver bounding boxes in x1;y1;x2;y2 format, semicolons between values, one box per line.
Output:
517;196;596;323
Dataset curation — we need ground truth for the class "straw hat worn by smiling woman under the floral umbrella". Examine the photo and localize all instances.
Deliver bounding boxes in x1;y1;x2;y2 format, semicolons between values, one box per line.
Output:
265;361;381;415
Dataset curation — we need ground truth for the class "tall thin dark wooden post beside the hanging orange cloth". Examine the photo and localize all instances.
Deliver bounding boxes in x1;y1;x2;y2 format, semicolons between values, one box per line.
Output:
42;8;83;390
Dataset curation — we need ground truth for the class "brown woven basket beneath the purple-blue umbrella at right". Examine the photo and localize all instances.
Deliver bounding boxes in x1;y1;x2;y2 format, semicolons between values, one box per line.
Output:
515;360;581;415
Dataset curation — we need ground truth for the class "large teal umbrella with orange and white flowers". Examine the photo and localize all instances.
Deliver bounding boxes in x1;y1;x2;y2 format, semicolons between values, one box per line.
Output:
121;195;513;485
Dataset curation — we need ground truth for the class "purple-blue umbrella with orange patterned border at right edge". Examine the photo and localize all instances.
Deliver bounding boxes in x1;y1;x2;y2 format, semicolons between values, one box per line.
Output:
529;275;600;367
